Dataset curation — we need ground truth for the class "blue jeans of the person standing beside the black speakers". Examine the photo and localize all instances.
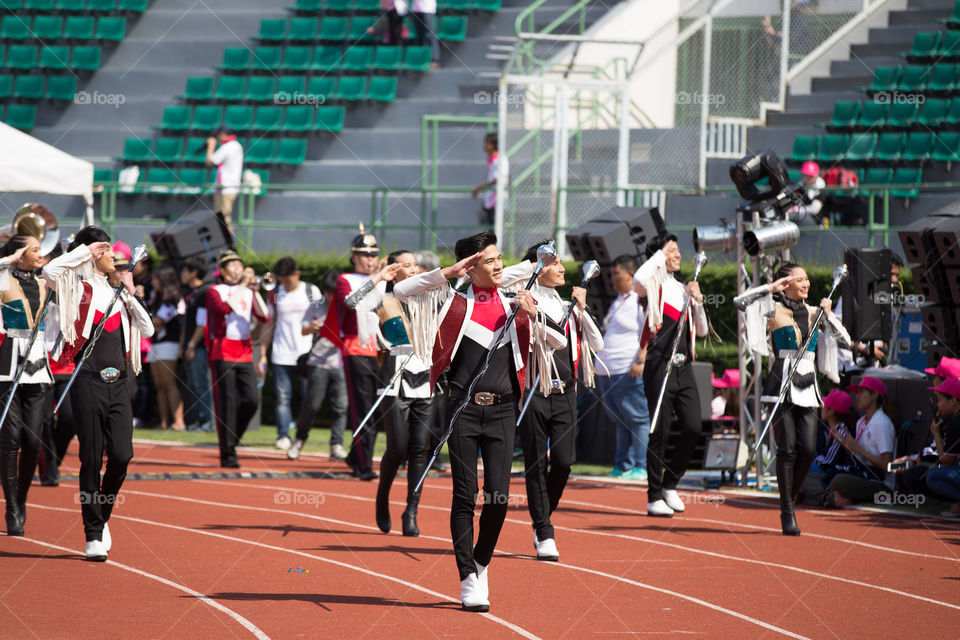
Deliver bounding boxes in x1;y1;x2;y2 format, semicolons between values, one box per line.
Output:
596;373;650;471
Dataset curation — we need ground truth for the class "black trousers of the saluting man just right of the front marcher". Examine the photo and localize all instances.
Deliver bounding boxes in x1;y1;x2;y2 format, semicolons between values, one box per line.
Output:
520;385;577;540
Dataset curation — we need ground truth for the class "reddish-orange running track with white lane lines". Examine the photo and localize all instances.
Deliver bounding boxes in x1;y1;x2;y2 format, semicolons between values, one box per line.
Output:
0;443;960;640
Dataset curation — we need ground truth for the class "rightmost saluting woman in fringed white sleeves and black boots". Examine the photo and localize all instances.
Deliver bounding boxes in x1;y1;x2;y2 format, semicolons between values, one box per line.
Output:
733;263;850;536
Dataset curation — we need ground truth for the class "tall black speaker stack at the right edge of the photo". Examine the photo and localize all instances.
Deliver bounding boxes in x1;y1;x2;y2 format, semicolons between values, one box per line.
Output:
896;201;960;366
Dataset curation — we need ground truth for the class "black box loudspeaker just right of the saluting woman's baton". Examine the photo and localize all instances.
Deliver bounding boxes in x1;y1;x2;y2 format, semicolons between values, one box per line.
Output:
842;248;893;342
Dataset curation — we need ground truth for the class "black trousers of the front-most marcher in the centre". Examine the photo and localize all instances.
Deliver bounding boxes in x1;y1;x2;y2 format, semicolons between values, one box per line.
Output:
447;397;517;580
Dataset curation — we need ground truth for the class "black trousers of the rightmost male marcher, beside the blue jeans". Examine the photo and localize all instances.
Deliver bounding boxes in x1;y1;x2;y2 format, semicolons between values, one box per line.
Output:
643;360;701;502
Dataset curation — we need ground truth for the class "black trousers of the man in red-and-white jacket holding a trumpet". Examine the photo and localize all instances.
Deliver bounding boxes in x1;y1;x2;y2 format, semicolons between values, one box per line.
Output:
211;360;258;465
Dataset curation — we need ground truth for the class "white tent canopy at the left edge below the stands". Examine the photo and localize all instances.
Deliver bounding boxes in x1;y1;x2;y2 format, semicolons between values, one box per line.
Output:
0;122;93;226
